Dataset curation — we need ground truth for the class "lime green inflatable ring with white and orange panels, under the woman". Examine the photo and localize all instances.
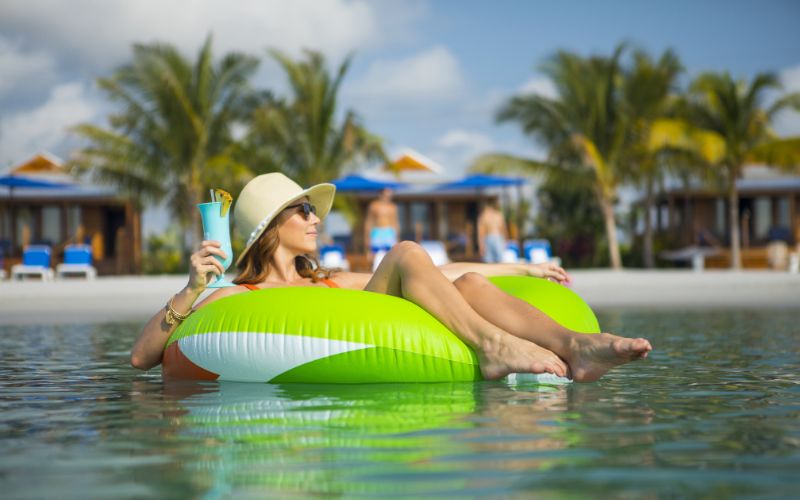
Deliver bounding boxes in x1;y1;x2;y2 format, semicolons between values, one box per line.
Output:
163;276;600;384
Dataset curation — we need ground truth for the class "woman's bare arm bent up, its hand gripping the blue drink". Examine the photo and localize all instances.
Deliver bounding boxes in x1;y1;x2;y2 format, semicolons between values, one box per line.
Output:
131;241;241;370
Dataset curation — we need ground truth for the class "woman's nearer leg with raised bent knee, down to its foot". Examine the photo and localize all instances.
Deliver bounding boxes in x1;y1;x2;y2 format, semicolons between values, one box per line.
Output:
364;241;567;380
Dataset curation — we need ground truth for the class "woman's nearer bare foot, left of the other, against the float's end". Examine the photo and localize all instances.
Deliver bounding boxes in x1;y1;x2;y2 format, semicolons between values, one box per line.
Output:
478;333;568;380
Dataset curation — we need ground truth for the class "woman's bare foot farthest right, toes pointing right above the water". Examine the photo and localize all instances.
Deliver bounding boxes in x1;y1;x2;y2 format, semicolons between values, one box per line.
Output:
568;333;653;382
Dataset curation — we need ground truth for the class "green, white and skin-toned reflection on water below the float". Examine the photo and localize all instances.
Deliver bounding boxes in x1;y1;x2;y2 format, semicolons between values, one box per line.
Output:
136;382;580;494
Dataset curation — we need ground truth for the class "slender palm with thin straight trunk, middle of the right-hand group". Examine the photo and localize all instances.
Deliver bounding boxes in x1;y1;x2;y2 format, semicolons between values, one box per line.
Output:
622;50;683;268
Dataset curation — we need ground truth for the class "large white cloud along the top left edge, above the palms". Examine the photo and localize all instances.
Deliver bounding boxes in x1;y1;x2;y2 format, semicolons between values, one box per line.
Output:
0;0;388;69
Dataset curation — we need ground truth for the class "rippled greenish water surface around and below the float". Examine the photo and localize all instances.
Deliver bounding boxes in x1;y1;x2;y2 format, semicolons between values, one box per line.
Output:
0;311;800;498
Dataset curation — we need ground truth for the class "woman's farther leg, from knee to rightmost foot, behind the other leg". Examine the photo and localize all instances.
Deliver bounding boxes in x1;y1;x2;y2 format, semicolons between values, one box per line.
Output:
453;273;652;382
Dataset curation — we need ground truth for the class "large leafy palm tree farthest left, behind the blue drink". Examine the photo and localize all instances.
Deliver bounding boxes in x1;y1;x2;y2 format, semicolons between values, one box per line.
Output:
70;36;258;252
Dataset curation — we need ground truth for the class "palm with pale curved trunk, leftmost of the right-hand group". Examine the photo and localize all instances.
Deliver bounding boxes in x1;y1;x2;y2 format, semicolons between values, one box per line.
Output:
472;45;629;269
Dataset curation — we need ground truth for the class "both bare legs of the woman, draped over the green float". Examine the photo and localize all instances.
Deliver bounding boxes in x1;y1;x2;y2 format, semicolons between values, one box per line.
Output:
365;241;651;381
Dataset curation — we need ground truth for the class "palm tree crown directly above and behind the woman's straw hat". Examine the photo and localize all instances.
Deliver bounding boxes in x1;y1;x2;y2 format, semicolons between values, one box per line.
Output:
245;50;386;185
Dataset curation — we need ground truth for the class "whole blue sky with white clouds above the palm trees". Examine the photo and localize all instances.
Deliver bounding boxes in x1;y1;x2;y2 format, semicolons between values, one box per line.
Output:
0;0;800;180
